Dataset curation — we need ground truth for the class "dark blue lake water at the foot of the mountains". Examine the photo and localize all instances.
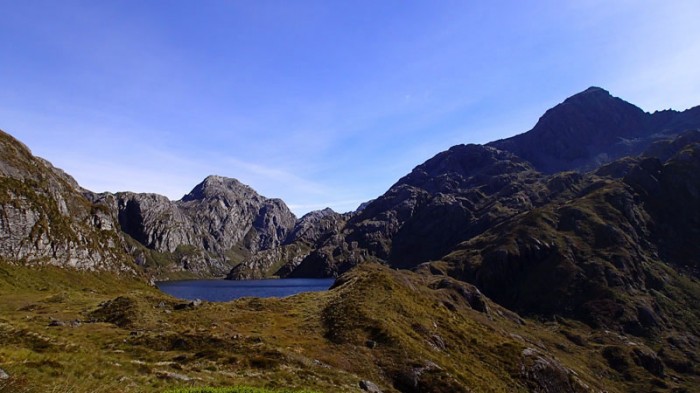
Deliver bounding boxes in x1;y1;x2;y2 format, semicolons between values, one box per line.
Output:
156;278;334;302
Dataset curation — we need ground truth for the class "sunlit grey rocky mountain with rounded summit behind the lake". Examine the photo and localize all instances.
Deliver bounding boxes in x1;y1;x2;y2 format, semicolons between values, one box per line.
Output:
92;176;296;276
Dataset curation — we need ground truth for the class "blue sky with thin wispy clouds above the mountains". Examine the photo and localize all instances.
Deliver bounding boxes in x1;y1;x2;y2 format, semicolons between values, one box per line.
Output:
0;0;700;216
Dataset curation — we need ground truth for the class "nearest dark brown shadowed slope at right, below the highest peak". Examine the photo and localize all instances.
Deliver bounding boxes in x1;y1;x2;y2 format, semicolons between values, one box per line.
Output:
438;132;700;336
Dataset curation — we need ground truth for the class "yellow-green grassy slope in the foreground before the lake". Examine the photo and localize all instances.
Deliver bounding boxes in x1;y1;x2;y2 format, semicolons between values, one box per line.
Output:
0;264;697;393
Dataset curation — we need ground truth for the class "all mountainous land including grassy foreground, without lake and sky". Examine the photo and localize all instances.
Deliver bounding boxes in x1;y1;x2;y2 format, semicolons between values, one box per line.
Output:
0;88;700;392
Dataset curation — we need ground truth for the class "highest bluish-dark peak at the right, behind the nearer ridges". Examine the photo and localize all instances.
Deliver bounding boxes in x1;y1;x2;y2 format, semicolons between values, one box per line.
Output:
489;87;700;173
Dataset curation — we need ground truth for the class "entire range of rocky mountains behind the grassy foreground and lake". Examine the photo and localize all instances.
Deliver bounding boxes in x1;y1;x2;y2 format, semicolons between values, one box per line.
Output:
0;87;700;392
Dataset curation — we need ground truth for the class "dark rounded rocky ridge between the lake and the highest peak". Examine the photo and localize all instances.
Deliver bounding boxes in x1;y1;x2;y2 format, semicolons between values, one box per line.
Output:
292;145;541;275
